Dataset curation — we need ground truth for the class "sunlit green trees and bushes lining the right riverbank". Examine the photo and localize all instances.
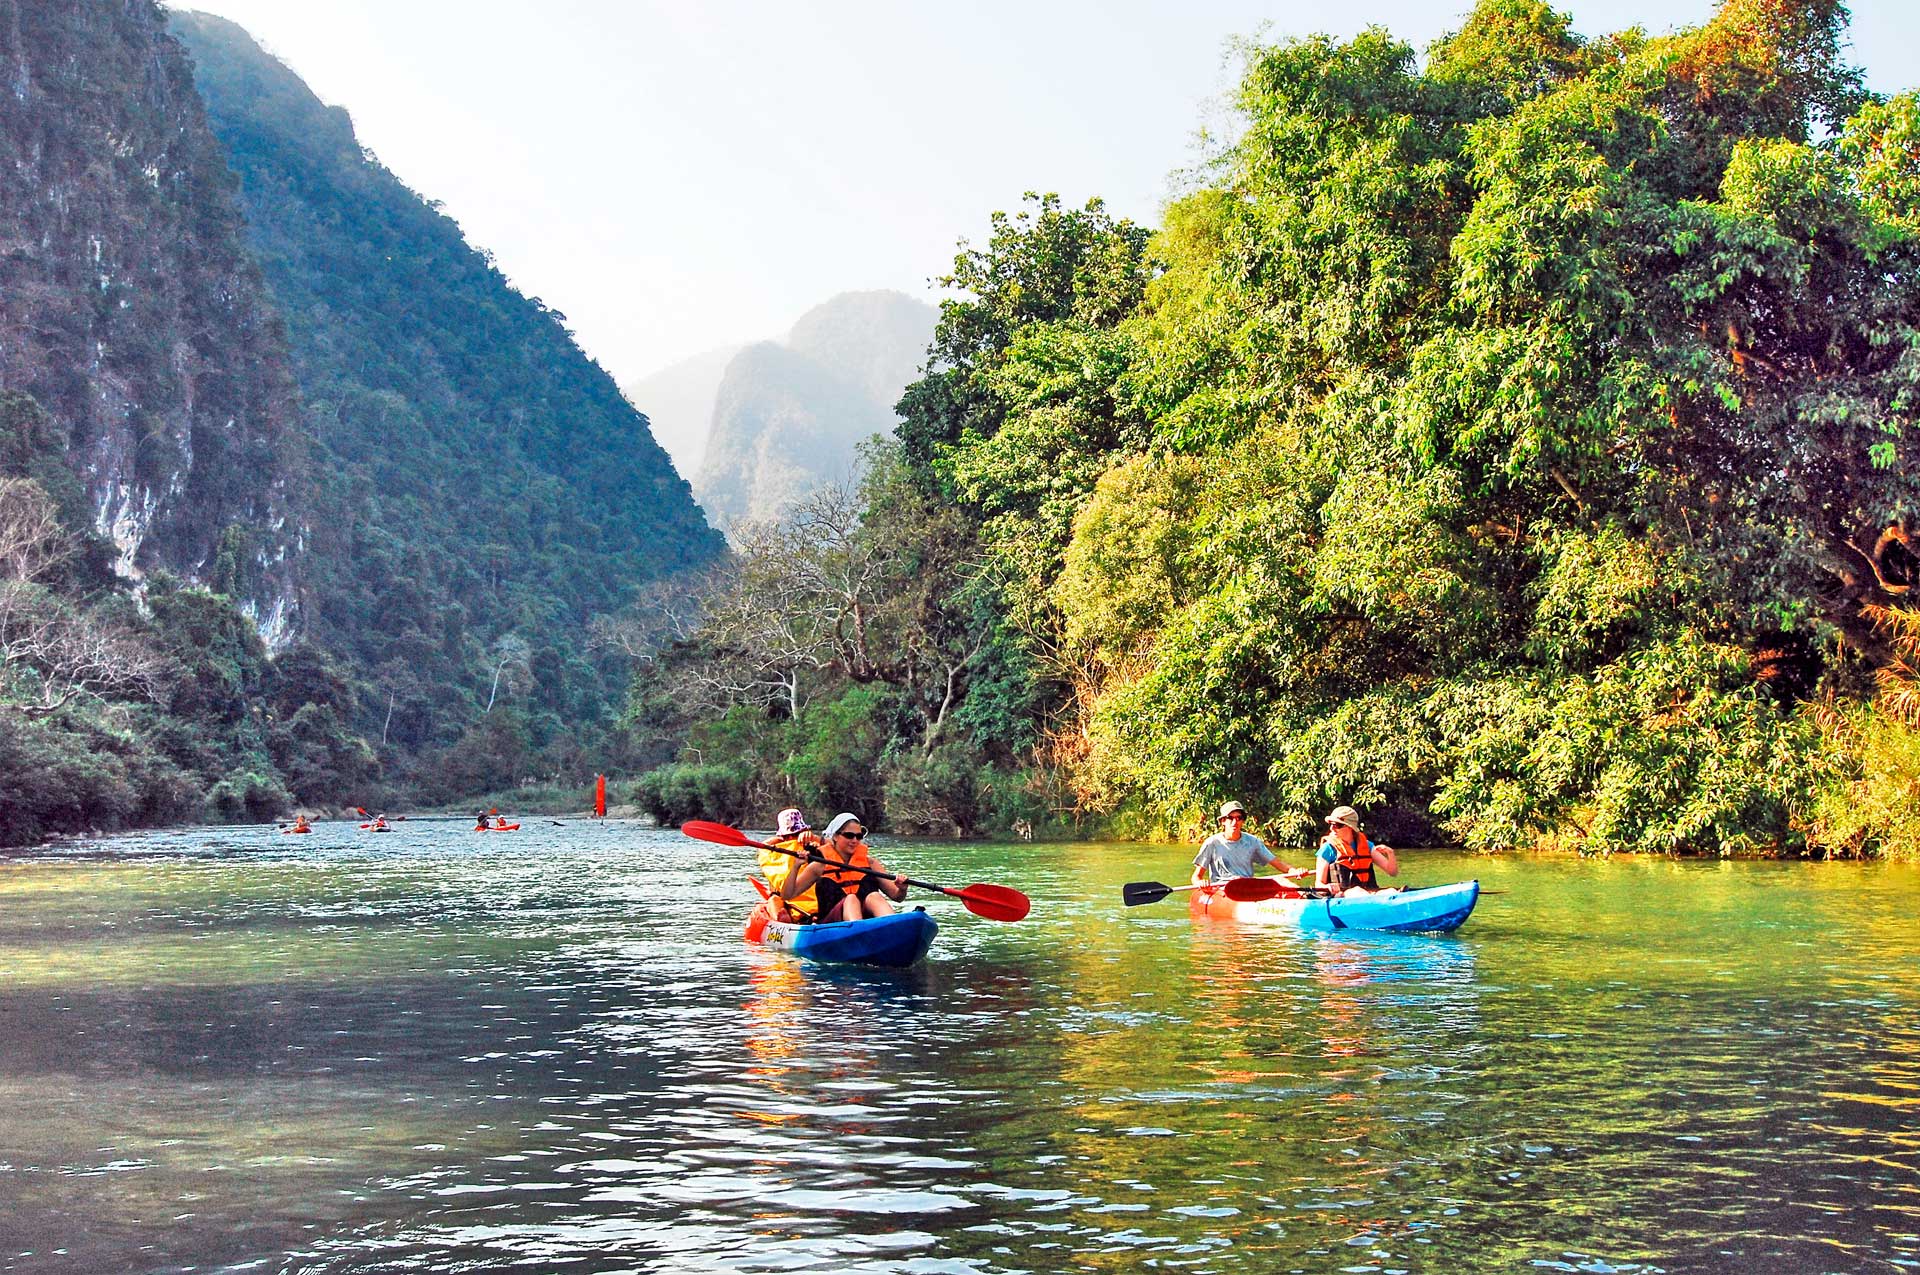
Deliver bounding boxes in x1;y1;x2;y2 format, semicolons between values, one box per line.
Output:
636;0;1920;854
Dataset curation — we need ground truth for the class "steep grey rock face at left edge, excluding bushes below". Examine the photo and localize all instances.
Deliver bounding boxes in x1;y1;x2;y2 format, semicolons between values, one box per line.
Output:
0;0;303;645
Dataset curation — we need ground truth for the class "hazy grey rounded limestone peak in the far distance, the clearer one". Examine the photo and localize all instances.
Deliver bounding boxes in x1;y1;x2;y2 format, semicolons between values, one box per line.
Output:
695;292;939;524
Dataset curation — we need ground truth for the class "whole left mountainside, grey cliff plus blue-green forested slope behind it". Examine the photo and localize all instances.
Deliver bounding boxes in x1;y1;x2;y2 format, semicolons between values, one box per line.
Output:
0;9;724;843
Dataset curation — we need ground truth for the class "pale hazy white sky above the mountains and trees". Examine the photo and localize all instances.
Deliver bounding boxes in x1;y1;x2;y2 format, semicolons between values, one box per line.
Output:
169;0;1920;382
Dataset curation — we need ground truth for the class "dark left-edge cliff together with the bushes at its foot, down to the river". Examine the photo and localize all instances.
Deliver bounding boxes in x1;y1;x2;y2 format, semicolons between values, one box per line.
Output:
0;4;374;845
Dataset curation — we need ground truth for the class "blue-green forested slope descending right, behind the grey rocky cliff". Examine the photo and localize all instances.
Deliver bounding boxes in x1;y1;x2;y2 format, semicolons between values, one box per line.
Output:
171;13;722;795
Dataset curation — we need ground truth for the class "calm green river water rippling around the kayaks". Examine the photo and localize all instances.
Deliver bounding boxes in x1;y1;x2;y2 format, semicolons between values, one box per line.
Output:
0;820;1920;1273
